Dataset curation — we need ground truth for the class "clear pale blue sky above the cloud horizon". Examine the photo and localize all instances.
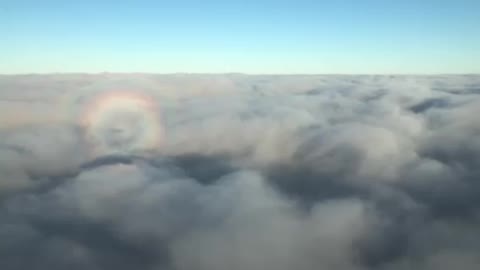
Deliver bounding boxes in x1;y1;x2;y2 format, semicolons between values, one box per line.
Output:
0;0;480;74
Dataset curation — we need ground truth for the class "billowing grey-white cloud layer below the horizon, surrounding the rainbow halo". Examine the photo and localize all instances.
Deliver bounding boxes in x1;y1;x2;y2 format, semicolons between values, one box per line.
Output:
0;74;480;270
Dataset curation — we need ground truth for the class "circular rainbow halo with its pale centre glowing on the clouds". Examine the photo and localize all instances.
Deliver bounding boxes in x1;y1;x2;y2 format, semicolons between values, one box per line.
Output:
80;90;163;156
